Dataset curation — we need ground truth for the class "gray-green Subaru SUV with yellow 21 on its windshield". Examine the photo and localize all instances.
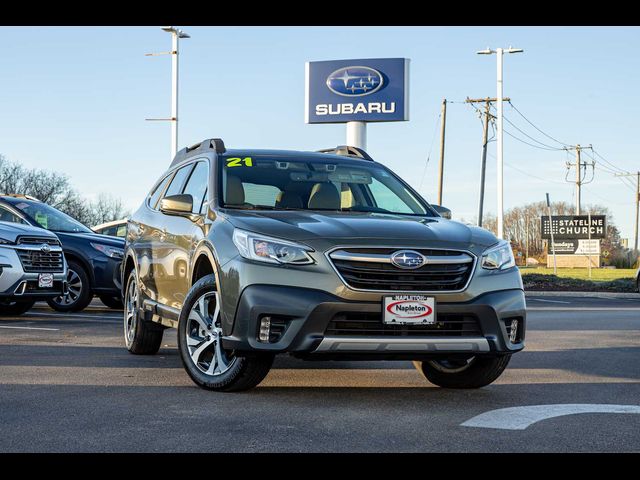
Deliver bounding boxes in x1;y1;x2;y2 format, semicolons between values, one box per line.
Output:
122;139;526;391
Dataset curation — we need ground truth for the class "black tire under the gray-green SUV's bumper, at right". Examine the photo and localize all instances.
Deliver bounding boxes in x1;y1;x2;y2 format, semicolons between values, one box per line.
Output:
413;355;511;389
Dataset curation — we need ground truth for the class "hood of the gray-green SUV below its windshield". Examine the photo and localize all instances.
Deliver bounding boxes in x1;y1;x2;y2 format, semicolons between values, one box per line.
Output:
227;210;498;250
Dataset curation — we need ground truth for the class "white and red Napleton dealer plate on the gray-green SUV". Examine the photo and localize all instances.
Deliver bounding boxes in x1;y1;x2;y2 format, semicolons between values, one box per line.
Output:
382;295;436;325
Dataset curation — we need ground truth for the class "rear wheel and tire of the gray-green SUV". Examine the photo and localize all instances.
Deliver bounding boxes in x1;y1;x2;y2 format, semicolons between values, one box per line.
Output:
123;270;164;355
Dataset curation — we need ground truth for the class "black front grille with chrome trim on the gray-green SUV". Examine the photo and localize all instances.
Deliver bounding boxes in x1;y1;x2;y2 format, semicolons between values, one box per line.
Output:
329;248;475;292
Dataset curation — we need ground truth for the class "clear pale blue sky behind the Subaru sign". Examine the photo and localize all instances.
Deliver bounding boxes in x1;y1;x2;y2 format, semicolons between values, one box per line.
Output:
0;26;640;238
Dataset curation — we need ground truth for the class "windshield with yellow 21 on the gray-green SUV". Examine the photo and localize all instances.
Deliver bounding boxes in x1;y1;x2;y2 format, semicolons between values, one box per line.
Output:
220;156;433;216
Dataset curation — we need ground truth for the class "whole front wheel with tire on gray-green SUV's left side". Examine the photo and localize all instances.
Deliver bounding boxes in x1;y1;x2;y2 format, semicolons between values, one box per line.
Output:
178;275;274;392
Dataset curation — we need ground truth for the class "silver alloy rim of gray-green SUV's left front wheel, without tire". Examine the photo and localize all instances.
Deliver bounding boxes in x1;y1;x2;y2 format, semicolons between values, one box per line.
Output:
185;292;237;376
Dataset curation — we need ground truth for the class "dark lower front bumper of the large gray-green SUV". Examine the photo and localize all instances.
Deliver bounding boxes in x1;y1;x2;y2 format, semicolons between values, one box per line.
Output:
223;285;526;359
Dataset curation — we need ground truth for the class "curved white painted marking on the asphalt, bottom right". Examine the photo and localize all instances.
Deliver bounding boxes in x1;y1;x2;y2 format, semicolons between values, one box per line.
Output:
460;403;640;430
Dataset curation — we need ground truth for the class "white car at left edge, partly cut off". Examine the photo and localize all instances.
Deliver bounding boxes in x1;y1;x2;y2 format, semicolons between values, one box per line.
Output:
0;219;67;315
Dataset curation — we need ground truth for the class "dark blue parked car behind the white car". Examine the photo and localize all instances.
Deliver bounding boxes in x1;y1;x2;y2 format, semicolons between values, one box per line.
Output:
0;194;124;312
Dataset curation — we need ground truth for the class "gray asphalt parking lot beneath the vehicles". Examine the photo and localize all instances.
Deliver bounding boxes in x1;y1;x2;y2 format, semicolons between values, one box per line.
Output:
0;294;640;452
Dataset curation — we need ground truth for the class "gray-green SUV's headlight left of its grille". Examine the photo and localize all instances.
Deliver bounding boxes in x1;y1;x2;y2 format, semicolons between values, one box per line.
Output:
233;228;313;265
